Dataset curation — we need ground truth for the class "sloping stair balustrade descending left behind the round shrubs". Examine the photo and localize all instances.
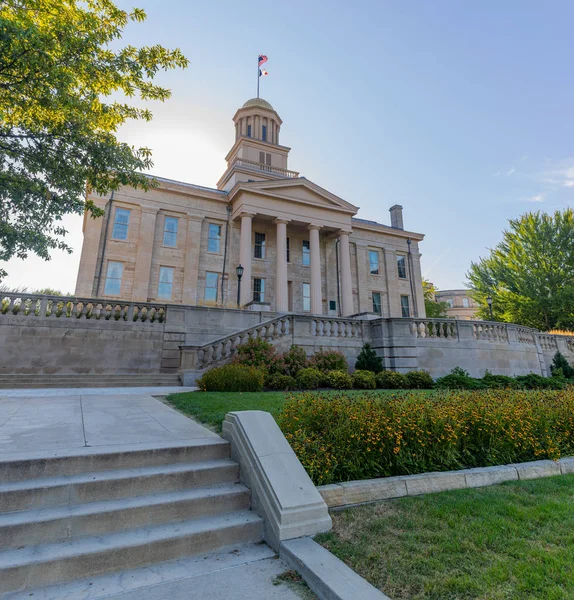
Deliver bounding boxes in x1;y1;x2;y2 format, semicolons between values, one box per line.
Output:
181;315;293;371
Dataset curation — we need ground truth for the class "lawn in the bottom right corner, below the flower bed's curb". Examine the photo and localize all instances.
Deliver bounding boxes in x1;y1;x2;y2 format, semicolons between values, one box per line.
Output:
316;475;574;600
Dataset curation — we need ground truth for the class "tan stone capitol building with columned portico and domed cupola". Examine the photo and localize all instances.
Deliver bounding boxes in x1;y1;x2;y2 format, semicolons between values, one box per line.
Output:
76;98;425;317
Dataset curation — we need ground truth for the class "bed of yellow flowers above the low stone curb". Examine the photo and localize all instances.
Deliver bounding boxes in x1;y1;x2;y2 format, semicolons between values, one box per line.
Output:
278;389;574;485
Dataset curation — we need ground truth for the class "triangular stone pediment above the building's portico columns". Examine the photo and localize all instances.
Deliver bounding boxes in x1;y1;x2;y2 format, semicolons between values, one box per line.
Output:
230;177;358;215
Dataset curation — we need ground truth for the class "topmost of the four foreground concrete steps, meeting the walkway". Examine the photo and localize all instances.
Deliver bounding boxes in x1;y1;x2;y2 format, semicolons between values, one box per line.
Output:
0;436;229;482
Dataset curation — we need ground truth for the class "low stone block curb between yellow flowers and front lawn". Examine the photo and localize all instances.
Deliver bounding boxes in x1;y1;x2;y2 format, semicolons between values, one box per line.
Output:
317;457;574;508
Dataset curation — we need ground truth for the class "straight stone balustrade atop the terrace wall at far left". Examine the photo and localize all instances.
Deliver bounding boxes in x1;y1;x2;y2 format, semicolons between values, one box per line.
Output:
0;292;166;323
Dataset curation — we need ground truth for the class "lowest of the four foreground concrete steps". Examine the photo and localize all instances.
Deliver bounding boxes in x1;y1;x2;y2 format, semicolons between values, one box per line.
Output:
0;511;263;593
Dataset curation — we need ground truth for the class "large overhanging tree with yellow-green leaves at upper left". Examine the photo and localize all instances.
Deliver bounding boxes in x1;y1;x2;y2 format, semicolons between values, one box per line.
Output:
0;0;188;278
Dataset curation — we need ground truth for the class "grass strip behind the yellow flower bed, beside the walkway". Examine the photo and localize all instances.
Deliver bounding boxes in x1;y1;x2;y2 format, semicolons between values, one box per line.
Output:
167;390;408;433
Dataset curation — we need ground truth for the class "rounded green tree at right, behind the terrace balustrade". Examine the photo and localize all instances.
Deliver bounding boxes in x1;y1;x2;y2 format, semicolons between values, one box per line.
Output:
467;208;574;331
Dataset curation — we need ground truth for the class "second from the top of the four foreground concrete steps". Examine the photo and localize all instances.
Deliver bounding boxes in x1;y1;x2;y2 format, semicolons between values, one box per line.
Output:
0;459;239;513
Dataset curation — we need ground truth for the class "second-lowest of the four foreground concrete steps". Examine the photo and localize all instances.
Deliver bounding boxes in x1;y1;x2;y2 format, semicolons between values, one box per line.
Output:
0;483;250;549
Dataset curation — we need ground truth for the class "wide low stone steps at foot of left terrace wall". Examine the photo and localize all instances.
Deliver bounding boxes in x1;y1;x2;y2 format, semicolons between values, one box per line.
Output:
0;373;181;389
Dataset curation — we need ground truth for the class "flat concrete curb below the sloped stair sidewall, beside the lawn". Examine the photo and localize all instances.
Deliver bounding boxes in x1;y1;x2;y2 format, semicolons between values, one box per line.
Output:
280;538;390;600
